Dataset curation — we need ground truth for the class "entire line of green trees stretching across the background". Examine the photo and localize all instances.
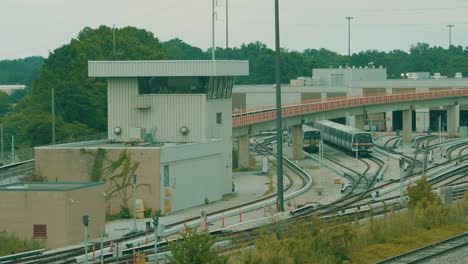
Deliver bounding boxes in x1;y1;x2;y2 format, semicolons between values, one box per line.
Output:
0;26;468;147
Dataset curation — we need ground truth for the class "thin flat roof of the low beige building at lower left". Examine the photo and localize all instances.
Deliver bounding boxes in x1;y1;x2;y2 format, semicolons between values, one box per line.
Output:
0;182;104;192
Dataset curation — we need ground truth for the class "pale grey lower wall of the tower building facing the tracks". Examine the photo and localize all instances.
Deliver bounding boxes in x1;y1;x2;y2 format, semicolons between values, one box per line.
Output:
160;140;232;213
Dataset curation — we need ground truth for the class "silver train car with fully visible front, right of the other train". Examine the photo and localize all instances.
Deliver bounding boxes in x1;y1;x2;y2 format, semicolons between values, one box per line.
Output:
315;120;374;154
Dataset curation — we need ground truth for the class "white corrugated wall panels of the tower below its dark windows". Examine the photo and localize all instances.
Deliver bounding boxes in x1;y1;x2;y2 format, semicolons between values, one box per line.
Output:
108;78;206;142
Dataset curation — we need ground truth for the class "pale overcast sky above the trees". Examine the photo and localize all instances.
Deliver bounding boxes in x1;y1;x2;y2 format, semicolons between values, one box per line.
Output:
0;0;468;59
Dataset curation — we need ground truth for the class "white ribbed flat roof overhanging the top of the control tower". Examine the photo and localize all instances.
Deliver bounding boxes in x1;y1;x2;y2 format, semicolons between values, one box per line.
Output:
88;60;249;77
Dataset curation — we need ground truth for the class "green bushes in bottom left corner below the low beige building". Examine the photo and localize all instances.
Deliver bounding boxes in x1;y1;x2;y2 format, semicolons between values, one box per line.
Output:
0;231;44;256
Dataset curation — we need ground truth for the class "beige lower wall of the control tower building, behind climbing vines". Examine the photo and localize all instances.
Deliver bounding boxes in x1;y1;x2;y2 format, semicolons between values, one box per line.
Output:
34;147;160;214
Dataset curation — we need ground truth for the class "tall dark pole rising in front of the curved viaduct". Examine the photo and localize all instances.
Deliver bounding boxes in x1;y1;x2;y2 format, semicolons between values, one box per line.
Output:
275;0;284;212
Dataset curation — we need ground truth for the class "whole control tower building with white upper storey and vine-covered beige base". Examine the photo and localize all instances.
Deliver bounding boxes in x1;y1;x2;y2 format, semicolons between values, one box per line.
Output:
35;61;248;216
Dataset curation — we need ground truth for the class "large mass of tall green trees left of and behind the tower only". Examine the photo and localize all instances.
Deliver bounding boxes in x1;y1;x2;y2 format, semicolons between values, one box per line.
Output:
0;26;167;146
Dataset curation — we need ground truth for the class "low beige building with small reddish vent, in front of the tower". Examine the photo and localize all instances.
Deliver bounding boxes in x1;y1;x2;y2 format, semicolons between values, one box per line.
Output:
0;182;105;249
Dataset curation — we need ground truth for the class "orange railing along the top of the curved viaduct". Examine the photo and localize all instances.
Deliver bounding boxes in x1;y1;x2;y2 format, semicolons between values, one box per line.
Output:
232;88;468;128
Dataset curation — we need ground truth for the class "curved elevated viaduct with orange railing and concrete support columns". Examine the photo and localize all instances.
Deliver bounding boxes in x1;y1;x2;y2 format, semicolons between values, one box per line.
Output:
232;88;468;168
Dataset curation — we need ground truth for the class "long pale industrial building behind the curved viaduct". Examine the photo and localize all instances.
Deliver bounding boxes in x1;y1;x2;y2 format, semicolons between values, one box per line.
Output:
233;67;468;136
